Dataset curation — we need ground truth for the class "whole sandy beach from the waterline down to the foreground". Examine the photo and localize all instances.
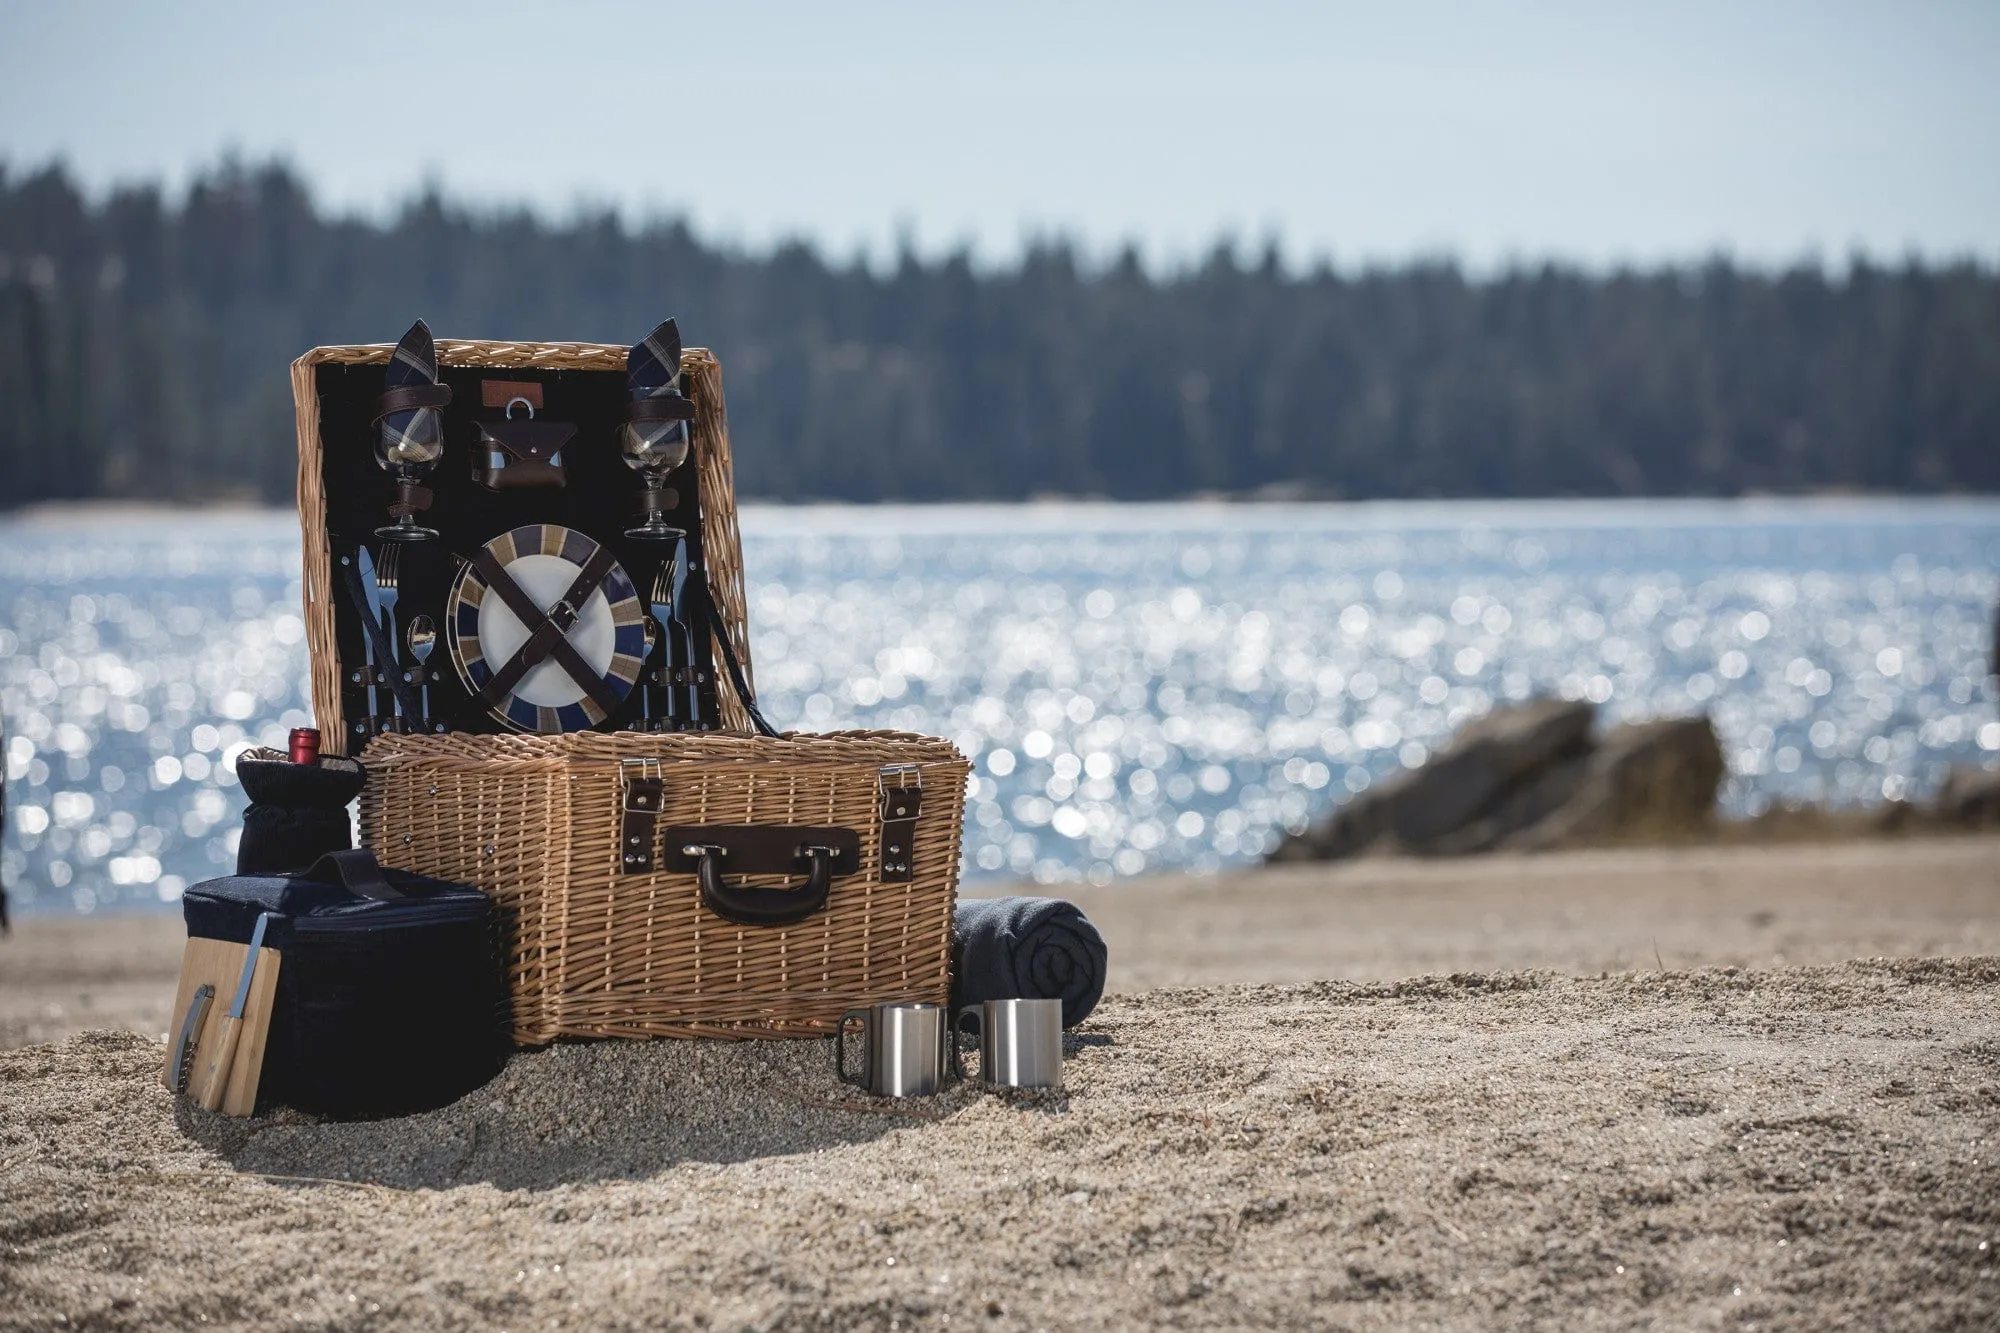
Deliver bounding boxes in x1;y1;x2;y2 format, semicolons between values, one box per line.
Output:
0;839;2000;1329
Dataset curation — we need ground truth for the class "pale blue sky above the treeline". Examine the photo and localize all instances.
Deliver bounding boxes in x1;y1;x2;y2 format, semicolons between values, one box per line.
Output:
0;0;2000;266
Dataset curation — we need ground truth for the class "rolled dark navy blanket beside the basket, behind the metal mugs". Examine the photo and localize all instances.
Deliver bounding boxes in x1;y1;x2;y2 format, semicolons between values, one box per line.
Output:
952;899;1106;1027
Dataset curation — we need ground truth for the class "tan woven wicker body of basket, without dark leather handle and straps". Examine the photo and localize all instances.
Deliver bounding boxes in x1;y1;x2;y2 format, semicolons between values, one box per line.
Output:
362;731;970;1045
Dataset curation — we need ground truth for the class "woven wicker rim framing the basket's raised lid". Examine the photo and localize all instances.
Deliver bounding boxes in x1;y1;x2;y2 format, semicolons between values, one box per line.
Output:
292;338;754;755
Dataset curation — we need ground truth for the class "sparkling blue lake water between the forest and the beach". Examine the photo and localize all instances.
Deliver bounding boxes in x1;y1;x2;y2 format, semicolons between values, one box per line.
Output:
0;500;2000;913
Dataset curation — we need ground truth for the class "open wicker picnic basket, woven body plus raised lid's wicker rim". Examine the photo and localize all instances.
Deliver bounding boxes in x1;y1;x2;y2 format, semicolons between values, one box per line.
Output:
292;340;970;1045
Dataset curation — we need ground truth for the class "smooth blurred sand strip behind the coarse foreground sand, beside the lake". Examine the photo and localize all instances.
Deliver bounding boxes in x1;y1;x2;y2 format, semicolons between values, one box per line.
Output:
0;837;2000;1049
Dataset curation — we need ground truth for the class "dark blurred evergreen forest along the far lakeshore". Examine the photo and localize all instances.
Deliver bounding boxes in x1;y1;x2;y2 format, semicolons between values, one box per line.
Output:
0;164;2000;504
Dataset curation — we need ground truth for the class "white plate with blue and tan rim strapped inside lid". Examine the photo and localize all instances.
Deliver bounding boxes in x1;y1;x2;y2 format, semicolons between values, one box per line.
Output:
444;522;646;735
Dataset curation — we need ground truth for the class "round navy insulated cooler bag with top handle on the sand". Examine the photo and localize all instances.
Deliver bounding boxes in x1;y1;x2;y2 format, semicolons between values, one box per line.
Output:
182;849;510;1119
